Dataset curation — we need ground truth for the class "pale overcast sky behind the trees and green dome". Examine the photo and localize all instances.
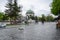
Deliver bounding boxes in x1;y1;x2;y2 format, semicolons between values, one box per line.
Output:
0;0;52;16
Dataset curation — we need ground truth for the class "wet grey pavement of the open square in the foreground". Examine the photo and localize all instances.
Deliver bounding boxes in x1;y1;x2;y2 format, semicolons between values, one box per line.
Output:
0;22;60;40
